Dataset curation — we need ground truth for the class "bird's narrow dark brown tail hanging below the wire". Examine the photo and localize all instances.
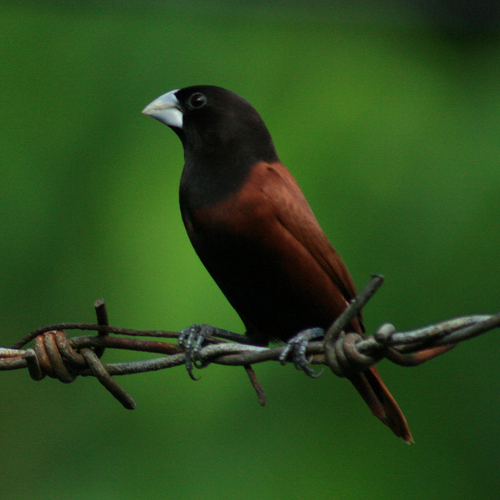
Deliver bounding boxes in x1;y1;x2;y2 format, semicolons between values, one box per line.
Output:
349;366;413;444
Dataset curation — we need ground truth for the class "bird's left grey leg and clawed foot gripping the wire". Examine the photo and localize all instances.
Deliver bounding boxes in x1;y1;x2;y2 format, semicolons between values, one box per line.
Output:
178;325;252;380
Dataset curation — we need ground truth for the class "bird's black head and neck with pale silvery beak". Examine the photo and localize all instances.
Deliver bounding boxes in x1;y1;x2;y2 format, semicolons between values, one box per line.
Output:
143;85;278;207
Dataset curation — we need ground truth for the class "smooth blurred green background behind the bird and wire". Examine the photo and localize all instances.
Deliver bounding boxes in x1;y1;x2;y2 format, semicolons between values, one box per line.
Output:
0;1;500;500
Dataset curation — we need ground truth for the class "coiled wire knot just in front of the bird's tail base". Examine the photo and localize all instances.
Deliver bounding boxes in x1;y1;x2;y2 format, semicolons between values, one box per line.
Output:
325;331;386;377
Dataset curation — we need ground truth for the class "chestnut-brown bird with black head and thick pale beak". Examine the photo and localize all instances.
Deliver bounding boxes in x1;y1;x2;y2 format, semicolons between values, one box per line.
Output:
143;85;413;443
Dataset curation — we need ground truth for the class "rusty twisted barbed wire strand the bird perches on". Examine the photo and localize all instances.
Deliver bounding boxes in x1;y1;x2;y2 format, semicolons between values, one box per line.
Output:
0;276;500;409
